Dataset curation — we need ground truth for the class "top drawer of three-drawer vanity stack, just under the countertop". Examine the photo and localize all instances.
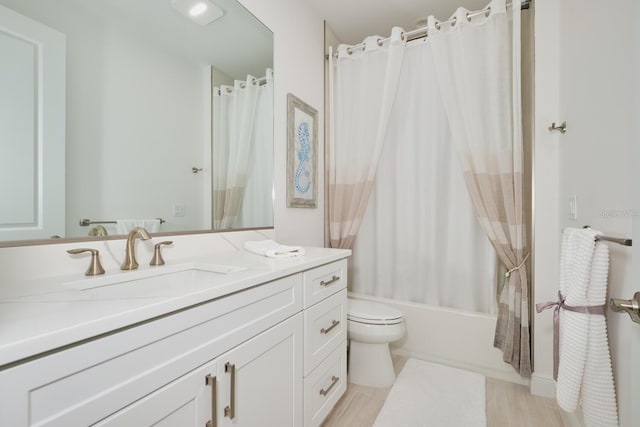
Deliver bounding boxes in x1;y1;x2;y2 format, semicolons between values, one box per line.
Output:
304;259;347;308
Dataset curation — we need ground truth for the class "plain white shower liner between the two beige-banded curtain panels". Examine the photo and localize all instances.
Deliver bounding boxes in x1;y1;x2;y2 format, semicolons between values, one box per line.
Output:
352;41;496;313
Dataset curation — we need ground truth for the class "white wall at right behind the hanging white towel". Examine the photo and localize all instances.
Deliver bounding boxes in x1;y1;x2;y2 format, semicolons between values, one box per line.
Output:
532;0;637;426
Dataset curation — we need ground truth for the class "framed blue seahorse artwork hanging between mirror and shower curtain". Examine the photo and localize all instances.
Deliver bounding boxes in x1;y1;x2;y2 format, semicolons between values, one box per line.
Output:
287;93;318;208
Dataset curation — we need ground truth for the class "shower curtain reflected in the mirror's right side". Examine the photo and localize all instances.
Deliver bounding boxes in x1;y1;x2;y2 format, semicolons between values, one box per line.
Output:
212;69;273;230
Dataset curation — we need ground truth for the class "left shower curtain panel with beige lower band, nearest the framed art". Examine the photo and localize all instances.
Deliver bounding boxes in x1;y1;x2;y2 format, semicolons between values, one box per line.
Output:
328;28;404;249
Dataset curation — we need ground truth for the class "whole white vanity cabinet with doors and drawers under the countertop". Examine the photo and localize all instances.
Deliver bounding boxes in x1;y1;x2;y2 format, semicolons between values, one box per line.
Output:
0;259;346;427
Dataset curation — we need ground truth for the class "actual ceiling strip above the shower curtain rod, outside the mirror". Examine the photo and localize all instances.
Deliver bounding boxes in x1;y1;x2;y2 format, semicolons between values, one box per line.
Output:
300;0;496;44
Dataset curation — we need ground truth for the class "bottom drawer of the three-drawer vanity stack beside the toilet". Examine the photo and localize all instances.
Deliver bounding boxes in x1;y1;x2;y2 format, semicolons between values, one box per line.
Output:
304;340;347;427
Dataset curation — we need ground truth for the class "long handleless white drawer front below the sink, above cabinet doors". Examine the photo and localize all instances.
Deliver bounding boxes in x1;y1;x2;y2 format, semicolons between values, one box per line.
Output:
0;274;302;427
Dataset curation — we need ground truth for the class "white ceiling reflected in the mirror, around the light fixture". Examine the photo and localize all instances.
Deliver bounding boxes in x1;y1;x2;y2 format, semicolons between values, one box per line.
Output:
0;0;273;79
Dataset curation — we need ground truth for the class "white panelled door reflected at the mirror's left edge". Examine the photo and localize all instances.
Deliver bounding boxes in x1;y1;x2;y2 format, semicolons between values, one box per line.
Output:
0;6;65;241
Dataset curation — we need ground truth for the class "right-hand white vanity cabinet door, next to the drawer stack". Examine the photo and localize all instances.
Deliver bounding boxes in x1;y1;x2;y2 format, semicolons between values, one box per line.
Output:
217;313;303;427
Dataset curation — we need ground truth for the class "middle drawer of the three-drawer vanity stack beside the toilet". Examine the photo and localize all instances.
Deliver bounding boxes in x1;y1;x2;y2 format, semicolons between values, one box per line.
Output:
304;289;347;375
